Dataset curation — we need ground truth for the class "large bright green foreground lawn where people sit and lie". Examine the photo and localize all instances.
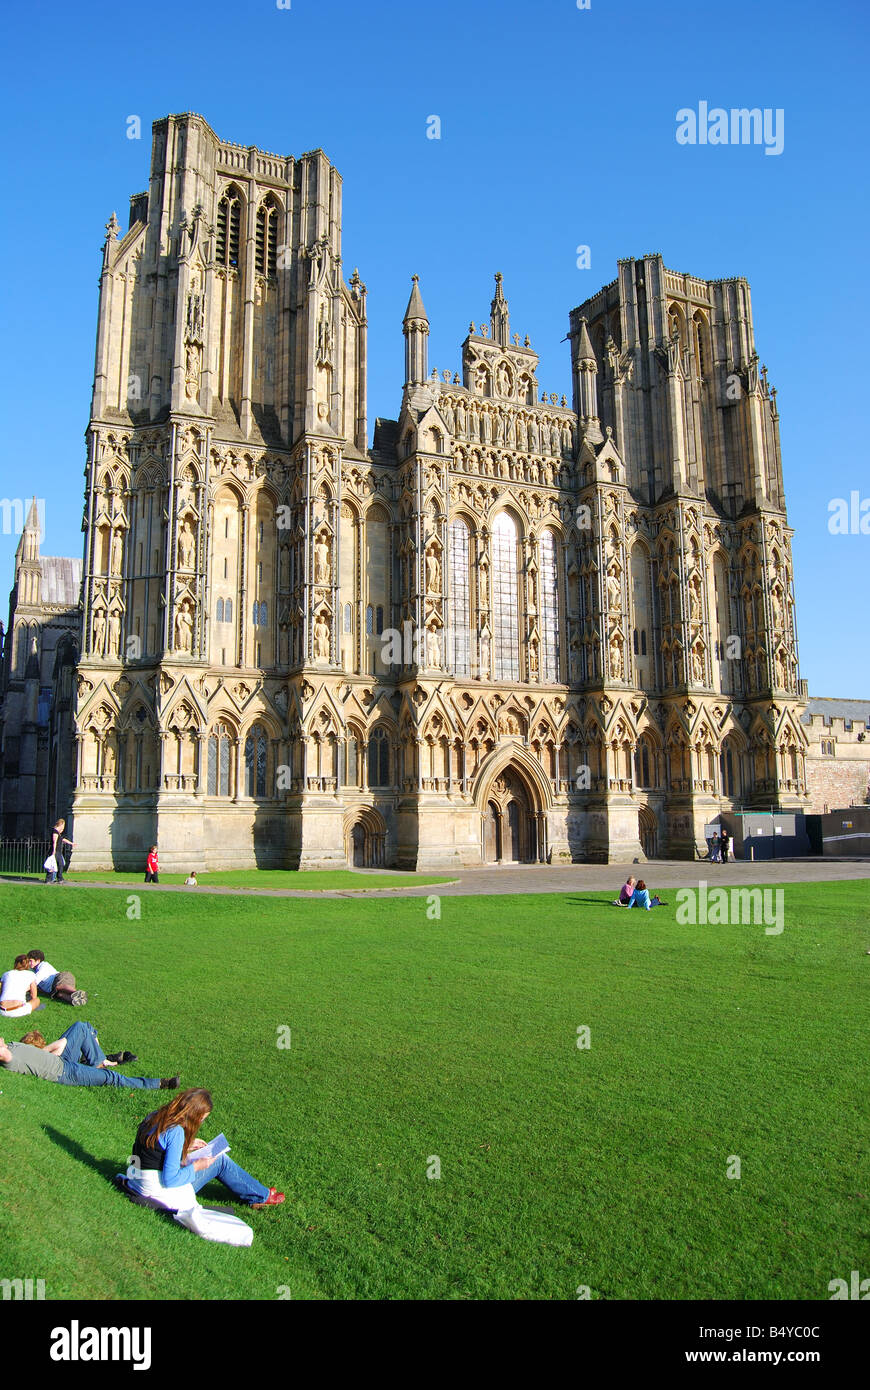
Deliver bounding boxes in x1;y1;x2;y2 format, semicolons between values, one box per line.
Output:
0;883;870;1300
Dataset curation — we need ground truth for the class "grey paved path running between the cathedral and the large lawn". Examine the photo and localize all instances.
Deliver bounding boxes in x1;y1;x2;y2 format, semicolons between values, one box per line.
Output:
0;859;870;898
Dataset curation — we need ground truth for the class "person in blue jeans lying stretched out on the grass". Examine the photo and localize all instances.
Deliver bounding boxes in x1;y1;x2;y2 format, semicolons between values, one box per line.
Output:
0;1022;178;1091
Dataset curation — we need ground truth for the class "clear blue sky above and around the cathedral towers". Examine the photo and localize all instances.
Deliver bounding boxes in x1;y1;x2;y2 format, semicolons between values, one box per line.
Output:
0;0;870;698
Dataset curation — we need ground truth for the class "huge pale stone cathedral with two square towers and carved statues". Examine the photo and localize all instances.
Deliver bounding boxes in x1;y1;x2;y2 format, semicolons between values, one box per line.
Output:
68;114;807;870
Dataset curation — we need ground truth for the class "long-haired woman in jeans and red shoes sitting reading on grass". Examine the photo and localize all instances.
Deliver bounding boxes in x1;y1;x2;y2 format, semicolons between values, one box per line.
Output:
126;1090;284;1211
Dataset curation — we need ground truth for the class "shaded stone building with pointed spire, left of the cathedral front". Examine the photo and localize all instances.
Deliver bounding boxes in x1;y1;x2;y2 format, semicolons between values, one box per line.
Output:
0;499;82;840
